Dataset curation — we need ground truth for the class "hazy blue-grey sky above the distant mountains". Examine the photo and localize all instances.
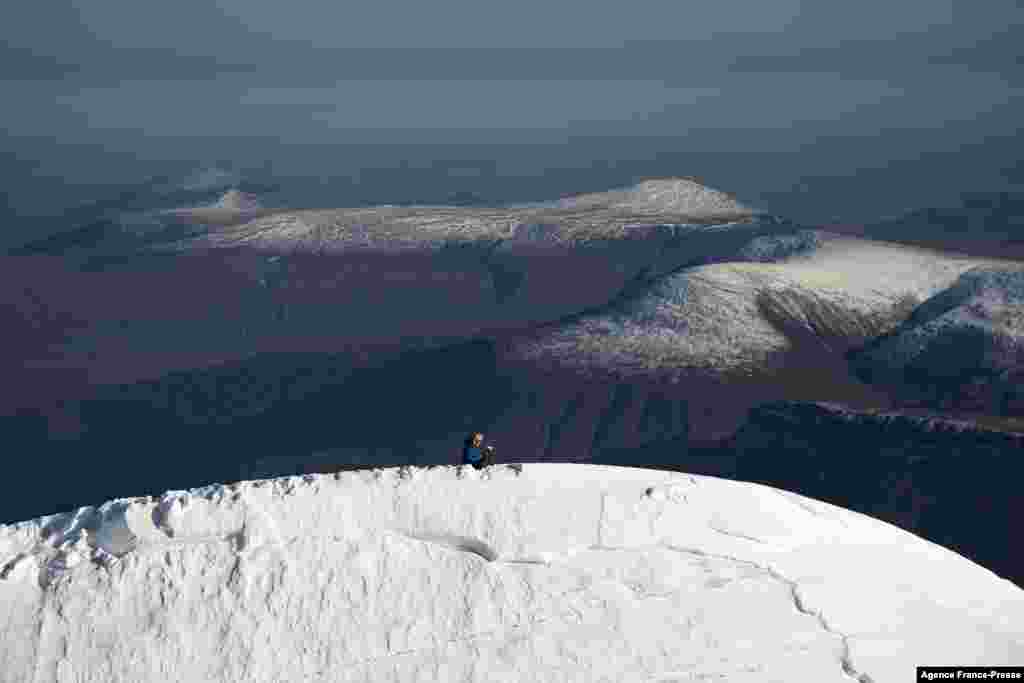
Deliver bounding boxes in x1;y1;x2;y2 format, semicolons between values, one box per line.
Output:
0;0;1024;239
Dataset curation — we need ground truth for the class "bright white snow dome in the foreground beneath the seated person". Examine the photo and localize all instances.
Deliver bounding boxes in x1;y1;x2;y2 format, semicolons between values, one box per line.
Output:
0;464;1024;683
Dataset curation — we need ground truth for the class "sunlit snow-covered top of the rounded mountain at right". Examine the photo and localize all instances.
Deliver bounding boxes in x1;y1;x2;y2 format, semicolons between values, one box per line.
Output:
510;230;985;375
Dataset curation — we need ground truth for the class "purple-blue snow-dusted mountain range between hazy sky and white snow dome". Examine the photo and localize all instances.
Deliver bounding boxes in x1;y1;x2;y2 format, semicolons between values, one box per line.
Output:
0;178;1024;589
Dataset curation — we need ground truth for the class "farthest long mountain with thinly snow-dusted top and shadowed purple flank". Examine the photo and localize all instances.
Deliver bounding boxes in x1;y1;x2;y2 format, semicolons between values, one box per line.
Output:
0;179;776;395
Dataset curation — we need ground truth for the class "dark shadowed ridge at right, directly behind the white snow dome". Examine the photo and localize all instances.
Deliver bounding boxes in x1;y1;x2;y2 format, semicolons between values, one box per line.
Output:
725;402;1024;586
